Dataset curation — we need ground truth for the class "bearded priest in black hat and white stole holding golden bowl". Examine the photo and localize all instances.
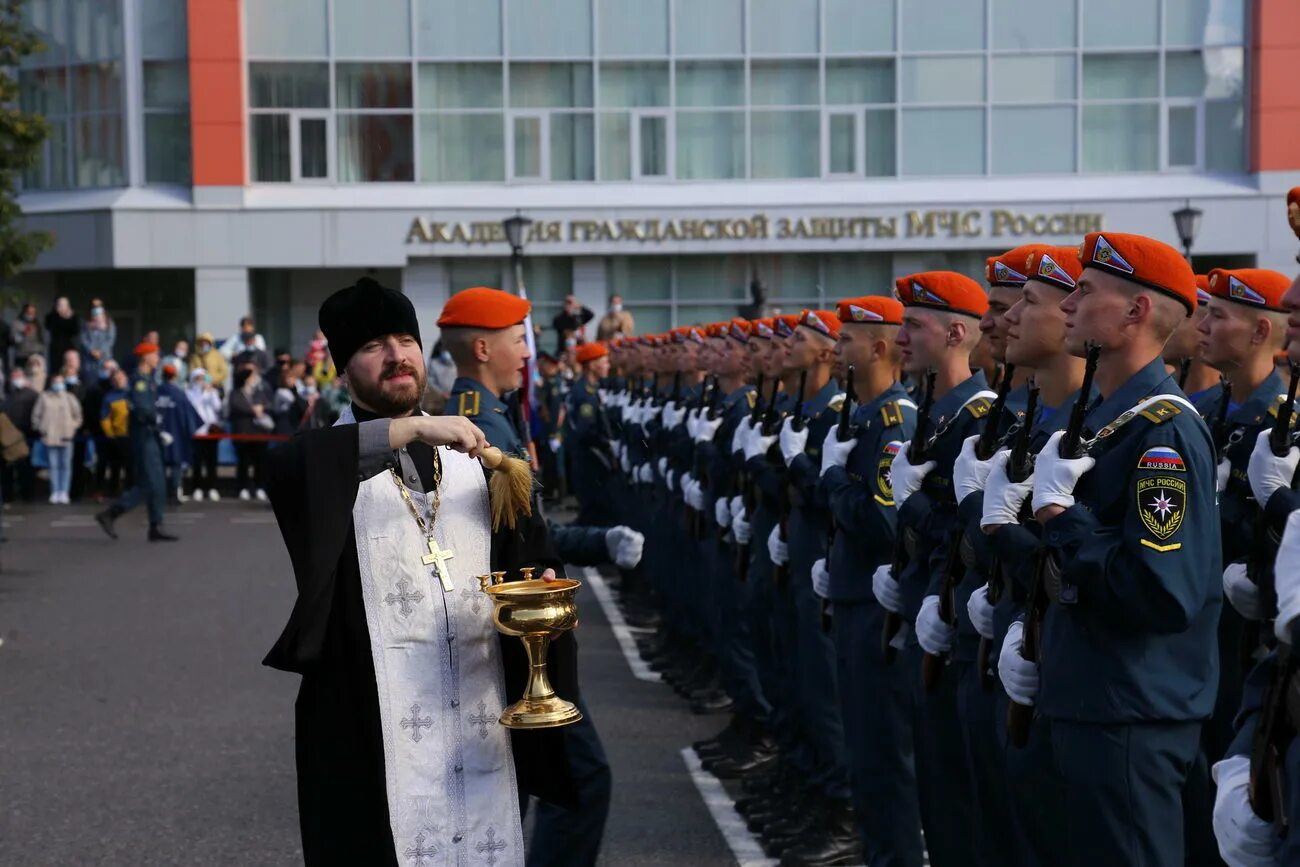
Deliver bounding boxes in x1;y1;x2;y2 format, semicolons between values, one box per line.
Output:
264;278;580;866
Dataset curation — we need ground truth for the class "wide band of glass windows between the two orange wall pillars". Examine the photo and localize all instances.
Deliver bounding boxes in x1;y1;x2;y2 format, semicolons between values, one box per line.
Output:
239;0;1248;183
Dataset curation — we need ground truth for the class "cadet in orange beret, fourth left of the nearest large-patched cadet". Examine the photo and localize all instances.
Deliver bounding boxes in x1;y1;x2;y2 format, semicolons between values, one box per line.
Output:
810;295;922;867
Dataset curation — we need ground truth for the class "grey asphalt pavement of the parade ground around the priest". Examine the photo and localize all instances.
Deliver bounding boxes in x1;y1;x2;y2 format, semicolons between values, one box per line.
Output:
0;502;735;867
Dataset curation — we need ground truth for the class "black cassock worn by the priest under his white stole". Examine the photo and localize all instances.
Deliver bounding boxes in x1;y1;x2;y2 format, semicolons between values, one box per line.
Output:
263;425;579;866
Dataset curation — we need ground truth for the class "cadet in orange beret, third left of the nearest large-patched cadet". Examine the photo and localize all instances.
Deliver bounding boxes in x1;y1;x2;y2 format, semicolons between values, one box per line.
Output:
872;272;995;867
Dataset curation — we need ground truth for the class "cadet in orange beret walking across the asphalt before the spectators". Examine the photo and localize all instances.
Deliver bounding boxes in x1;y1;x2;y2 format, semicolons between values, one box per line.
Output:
95;343;177;542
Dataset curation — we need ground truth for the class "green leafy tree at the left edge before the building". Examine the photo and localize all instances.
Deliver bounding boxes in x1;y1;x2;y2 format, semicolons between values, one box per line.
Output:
0;0;55;281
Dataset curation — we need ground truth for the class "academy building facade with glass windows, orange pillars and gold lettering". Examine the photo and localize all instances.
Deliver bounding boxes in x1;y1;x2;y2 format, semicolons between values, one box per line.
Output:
12;0;1300;351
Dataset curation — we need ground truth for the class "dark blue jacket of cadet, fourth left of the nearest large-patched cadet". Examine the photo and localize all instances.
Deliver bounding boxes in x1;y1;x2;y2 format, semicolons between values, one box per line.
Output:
819;383;917;602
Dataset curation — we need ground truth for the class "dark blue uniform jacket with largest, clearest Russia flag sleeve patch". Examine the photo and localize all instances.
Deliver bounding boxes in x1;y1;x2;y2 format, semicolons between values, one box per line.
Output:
1039;359;1223;723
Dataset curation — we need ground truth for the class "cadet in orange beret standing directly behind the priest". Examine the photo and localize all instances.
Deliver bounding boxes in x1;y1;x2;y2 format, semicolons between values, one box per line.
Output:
438;287;611;867
